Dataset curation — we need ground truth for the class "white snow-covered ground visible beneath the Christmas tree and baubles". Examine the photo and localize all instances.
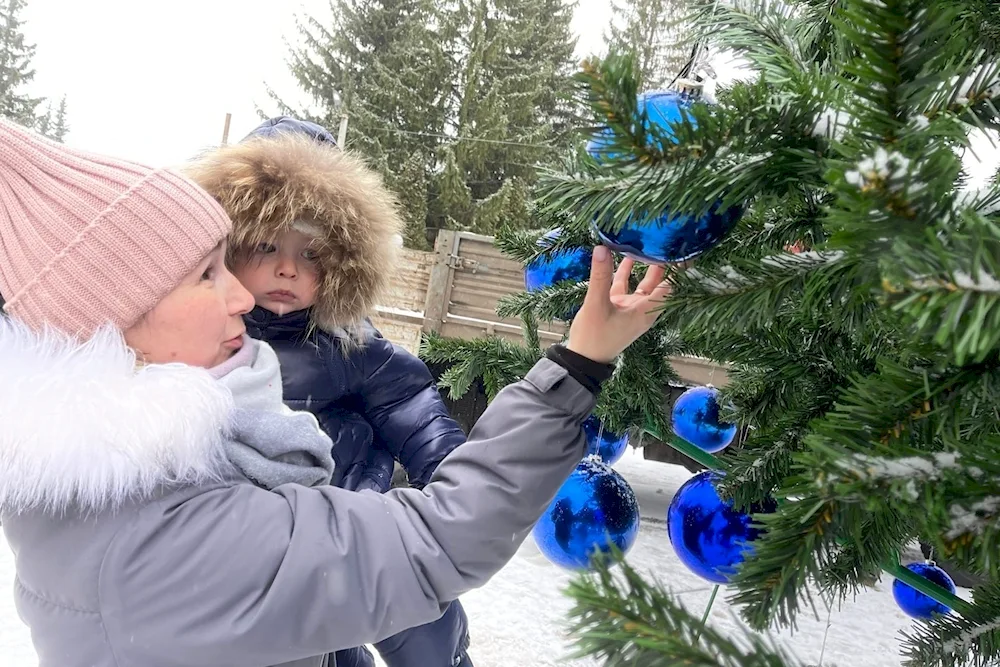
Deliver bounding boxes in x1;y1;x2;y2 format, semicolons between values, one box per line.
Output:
0;451;960;667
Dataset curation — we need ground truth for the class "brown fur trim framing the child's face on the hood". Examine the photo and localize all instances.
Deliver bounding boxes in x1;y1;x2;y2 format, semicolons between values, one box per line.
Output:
183;133;403;332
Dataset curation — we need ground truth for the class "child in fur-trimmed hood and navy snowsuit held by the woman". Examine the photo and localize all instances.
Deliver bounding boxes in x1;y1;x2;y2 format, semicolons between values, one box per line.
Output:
187;117;472;667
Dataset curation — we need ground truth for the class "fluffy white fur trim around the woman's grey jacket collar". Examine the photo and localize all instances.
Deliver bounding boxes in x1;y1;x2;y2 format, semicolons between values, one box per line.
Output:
0;316;232;512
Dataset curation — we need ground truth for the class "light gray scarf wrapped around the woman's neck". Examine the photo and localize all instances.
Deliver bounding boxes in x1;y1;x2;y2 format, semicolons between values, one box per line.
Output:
209;336;333;489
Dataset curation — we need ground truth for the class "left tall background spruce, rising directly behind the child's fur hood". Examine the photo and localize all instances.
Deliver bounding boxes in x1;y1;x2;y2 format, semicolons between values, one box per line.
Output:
271;0;454;247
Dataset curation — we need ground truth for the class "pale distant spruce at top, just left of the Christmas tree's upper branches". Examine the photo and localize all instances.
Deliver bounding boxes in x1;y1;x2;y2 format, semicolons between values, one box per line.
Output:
604;0;693;90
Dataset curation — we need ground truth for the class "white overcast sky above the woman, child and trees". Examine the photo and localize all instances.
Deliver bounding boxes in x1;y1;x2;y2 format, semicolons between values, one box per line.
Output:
15;0;997;180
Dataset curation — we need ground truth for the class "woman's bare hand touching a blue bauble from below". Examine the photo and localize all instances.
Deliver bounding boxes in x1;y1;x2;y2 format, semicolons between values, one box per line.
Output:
566;246;670;363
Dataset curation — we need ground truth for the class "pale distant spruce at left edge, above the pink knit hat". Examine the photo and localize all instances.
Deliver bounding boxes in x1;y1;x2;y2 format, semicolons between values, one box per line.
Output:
0;0;43;127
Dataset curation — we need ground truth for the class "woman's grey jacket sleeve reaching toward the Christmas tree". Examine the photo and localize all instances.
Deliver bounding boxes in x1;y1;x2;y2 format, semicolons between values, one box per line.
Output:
99;359;594;667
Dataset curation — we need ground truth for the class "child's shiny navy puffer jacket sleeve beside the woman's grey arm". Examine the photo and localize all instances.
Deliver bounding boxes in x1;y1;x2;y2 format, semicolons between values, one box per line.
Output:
329;329;465;488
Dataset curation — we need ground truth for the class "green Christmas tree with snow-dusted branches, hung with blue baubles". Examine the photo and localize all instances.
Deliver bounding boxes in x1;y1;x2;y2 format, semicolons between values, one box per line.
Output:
426;0;1000;665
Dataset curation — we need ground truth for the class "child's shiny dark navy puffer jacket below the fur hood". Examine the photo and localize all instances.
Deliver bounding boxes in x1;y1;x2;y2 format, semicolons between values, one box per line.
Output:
244;308;465;493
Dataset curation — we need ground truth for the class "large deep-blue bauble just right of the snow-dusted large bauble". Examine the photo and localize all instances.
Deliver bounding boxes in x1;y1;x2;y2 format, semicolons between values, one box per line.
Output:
667;470;776;584
